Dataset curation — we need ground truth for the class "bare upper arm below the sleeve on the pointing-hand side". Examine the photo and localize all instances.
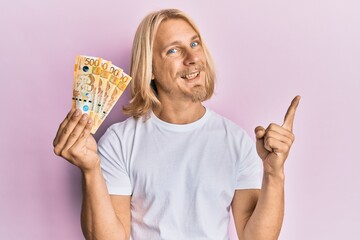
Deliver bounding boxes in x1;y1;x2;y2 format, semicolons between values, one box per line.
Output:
231;189;260;239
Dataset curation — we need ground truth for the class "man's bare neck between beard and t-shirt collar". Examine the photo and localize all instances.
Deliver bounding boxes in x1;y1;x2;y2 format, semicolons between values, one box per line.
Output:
154;102;205;124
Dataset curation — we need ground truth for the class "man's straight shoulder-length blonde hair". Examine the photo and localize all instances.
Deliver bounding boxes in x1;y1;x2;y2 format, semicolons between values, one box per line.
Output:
123;9;215;118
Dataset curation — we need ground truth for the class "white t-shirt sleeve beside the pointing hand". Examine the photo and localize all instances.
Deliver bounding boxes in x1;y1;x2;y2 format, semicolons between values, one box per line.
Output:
235;133;263;189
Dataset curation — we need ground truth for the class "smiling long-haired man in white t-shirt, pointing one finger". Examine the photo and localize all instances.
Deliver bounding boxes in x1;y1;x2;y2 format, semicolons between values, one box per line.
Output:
54;9;300;240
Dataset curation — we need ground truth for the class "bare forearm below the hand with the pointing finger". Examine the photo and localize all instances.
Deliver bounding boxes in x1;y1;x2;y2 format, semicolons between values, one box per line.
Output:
242;172;284;240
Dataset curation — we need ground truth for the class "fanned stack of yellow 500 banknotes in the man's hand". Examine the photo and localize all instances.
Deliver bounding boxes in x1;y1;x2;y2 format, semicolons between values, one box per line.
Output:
72;55;131;134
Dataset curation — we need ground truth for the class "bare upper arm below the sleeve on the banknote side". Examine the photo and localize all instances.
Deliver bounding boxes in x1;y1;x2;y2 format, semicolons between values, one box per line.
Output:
110;195;131;239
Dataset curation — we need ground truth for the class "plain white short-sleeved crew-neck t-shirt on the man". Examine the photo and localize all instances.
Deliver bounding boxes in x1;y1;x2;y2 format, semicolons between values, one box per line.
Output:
99;108;262;240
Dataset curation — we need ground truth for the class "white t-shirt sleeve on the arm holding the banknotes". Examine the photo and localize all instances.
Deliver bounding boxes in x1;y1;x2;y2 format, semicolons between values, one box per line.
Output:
98;127;132;195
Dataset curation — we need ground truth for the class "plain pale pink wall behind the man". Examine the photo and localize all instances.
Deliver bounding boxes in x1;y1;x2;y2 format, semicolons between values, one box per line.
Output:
0;0;360;240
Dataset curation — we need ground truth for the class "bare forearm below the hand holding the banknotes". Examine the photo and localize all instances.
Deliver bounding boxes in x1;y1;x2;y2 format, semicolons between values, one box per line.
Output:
81;167;126;240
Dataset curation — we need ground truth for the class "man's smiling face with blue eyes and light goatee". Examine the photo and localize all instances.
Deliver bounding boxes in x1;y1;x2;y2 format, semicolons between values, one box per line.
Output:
153;19;206;102
